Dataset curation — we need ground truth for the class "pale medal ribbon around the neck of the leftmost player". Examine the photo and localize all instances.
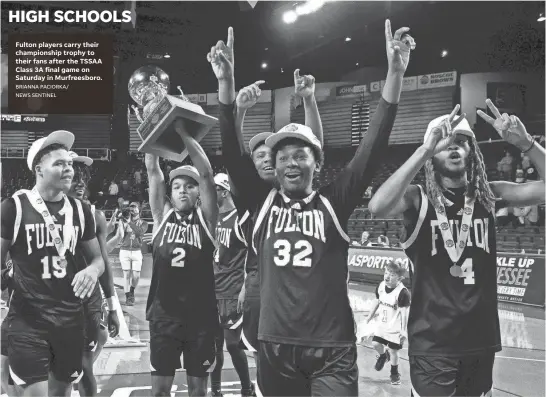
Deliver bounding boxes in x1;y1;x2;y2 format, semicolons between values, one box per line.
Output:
27;186;74;260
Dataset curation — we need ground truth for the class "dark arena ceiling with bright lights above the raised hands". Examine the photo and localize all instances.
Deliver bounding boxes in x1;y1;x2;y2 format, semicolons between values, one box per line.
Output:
2;1;544;92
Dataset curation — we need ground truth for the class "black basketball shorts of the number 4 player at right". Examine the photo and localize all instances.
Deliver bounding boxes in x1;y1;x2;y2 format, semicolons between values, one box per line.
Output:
409;353;495;397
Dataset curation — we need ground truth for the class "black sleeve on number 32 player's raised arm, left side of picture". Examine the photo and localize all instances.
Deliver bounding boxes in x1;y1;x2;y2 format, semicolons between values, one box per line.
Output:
219;103;271;213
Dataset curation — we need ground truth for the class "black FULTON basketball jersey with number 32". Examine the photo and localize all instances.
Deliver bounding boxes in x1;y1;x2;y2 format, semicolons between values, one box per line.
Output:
252;189;356;347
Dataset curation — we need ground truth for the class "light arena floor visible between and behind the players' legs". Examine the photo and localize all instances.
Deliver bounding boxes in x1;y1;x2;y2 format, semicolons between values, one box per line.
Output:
0;257;546;397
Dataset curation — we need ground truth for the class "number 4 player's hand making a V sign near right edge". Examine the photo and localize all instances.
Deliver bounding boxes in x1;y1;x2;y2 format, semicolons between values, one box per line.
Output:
478;99;532;150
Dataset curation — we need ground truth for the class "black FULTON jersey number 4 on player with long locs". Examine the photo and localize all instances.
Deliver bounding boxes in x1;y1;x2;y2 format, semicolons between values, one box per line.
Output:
401;186;501;356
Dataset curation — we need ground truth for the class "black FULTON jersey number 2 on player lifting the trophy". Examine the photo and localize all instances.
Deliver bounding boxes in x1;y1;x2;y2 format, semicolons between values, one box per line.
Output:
146;208;218;331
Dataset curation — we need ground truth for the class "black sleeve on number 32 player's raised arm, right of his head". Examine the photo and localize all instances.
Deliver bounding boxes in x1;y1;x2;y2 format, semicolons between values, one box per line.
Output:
321;98;398;224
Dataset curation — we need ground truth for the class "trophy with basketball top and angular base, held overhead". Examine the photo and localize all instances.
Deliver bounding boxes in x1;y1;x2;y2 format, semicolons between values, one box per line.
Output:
128;65;218;162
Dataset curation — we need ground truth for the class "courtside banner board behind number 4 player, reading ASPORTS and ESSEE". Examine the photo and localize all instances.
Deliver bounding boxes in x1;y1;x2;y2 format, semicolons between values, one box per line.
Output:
348;247;545;306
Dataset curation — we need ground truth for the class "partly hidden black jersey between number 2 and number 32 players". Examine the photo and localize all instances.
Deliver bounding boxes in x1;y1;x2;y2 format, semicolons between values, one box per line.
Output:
214;209;246;299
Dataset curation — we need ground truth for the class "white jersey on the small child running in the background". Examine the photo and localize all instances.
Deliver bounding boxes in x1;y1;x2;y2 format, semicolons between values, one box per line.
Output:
375;281;409;344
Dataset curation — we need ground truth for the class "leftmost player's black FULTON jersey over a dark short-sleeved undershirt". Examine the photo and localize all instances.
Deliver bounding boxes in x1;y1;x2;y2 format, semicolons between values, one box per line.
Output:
2;193;95;327
